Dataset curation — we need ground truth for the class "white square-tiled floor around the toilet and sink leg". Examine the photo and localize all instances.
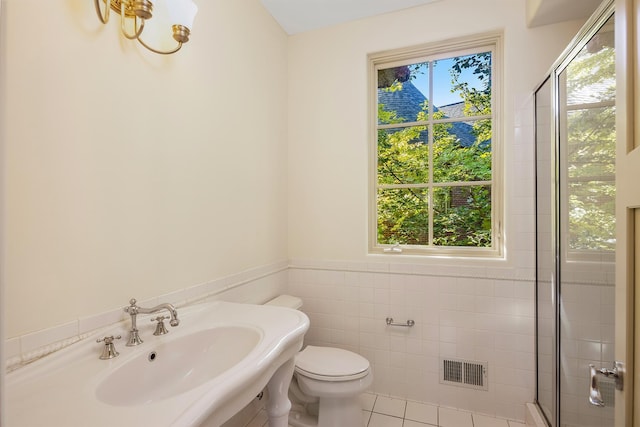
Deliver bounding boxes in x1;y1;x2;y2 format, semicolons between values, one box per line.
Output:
246;393;525;427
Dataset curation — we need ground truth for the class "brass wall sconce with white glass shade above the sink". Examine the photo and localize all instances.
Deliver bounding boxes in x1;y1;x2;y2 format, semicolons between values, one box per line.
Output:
94;0;198;55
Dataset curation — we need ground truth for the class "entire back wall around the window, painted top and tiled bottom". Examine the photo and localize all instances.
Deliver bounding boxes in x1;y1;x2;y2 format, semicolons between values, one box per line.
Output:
288;0;582;420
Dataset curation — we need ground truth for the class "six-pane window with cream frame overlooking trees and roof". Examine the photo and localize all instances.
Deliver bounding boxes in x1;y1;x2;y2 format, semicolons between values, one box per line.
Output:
369;34;502;256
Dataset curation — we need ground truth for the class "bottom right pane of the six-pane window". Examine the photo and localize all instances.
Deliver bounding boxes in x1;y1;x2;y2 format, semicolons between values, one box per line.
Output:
433;186;491;247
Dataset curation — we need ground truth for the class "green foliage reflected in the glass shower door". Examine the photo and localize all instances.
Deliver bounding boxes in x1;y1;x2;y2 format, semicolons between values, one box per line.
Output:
563;33;616;253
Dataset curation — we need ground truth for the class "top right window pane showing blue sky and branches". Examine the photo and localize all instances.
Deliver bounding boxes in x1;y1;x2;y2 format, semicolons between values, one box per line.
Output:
433;52;492;119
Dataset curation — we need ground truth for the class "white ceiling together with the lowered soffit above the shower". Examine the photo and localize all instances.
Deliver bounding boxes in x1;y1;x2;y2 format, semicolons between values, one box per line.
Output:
261;0;601;34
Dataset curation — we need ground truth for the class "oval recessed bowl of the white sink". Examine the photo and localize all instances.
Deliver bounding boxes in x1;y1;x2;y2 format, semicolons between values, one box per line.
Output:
96;326;262;406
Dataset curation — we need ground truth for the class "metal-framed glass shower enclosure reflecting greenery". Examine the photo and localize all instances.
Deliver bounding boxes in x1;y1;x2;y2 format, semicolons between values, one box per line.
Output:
535;1;616;427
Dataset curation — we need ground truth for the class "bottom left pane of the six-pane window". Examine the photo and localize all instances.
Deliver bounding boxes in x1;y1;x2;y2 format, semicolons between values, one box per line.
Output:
377;188;429;245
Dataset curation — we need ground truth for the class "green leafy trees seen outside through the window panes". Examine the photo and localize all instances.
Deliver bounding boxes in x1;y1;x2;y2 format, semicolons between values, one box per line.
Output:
377;52;492;247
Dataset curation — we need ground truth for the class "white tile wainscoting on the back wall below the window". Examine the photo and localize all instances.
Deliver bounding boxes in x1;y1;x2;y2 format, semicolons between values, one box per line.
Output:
288;260;535;420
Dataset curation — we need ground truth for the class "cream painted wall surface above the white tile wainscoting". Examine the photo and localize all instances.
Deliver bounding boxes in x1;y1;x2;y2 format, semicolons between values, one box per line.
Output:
0;0;580;338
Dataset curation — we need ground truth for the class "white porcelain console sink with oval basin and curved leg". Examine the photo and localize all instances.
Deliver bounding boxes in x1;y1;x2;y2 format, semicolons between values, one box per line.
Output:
3;301;309;427
